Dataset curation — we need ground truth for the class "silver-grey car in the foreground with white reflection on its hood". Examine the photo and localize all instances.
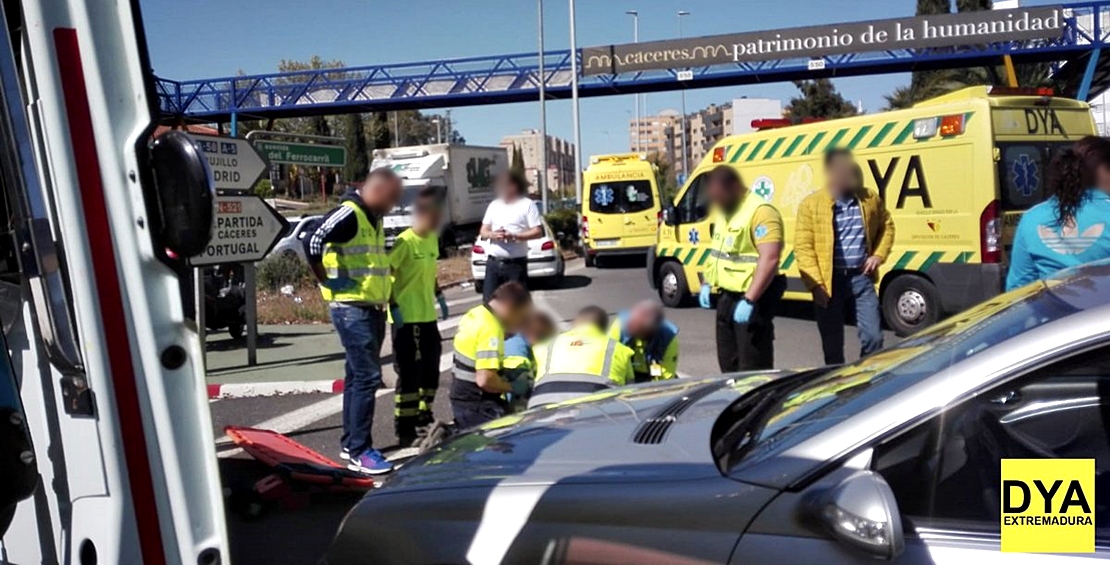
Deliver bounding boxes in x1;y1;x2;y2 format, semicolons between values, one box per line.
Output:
327;264;1110;565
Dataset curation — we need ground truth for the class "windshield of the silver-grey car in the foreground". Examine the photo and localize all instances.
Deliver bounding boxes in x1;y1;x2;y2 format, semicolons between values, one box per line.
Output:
715;279;1086;468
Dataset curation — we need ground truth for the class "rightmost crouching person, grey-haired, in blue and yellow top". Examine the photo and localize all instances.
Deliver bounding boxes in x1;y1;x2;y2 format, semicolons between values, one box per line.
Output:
609;300;678;383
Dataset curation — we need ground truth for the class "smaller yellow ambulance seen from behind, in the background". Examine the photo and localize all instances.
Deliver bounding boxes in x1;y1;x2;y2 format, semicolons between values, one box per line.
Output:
582;153;663;266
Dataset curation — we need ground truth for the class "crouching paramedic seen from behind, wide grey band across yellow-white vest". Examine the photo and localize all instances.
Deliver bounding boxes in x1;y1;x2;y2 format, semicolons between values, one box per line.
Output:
528;306;634;408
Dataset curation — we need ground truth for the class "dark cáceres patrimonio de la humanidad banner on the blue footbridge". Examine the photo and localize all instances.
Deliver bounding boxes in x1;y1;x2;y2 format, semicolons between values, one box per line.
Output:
582;7;1063;75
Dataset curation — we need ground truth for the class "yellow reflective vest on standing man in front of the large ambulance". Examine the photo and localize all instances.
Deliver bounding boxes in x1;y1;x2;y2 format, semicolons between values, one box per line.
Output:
705;192;770;292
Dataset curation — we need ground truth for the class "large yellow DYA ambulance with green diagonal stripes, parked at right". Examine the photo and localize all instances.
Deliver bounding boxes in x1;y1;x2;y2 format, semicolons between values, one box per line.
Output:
648;87;1096;334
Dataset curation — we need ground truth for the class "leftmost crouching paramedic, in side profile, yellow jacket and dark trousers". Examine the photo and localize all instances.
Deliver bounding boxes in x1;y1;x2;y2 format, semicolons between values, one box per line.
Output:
451;281;532;430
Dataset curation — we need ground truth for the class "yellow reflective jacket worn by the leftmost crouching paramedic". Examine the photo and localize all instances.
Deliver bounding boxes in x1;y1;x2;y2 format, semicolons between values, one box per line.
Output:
451;304;505;402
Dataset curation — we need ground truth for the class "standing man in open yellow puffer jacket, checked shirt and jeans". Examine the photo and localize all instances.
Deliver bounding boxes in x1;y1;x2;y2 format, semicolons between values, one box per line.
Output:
794;149;895;364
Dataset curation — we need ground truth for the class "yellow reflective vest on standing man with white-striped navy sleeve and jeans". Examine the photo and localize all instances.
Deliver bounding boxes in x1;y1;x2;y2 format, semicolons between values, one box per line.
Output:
320;201;392;304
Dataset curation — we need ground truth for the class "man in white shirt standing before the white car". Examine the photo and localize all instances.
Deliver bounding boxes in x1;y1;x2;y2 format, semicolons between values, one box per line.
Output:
481;171;544;302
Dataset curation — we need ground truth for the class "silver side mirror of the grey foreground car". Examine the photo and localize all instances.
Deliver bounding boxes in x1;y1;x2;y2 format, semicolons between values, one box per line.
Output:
816;471;905;559
